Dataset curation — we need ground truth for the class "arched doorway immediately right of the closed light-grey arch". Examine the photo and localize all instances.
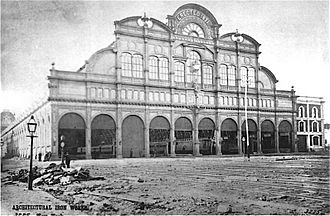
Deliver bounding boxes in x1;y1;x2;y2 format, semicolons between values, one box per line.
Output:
149;116;171;157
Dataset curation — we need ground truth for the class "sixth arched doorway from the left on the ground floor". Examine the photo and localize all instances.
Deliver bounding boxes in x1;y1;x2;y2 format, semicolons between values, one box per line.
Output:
198;118;216;155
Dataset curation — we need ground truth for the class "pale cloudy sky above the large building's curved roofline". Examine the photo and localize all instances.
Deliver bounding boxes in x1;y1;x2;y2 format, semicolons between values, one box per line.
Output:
0;0;330;120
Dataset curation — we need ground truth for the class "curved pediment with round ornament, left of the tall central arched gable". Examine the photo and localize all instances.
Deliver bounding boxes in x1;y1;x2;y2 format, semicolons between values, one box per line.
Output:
114;16;171;33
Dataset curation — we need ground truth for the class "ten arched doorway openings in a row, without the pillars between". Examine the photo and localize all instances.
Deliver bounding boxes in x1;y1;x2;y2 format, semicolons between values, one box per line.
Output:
58;113;292;159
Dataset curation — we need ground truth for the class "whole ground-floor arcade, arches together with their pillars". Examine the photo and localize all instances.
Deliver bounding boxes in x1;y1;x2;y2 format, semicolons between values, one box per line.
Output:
52;109;297;159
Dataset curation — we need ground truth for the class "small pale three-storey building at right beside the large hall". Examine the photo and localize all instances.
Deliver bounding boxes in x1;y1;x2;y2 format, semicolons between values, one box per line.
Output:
296;96;325;152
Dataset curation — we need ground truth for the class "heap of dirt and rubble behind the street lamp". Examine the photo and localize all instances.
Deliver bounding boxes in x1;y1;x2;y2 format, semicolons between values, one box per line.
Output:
3;163;105;185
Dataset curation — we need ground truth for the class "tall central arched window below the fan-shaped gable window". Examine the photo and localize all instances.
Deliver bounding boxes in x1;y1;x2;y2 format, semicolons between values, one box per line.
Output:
187;51;202;83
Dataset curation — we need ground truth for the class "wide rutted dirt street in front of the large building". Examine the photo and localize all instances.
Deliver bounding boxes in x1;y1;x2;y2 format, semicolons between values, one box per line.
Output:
1;155;330;215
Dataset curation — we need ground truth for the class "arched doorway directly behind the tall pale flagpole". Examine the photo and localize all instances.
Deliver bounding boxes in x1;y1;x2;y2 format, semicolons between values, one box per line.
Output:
241;119;258;153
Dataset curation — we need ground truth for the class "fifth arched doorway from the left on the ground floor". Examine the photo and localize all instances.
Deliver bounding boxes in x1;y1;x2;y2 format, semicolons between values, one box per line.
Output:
174;117;193;154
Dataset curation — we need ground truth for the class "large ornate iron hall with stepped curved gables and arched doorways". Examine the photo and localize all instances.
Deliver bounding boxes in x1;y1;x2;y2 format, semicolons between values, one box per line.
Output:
2;4;322;159
